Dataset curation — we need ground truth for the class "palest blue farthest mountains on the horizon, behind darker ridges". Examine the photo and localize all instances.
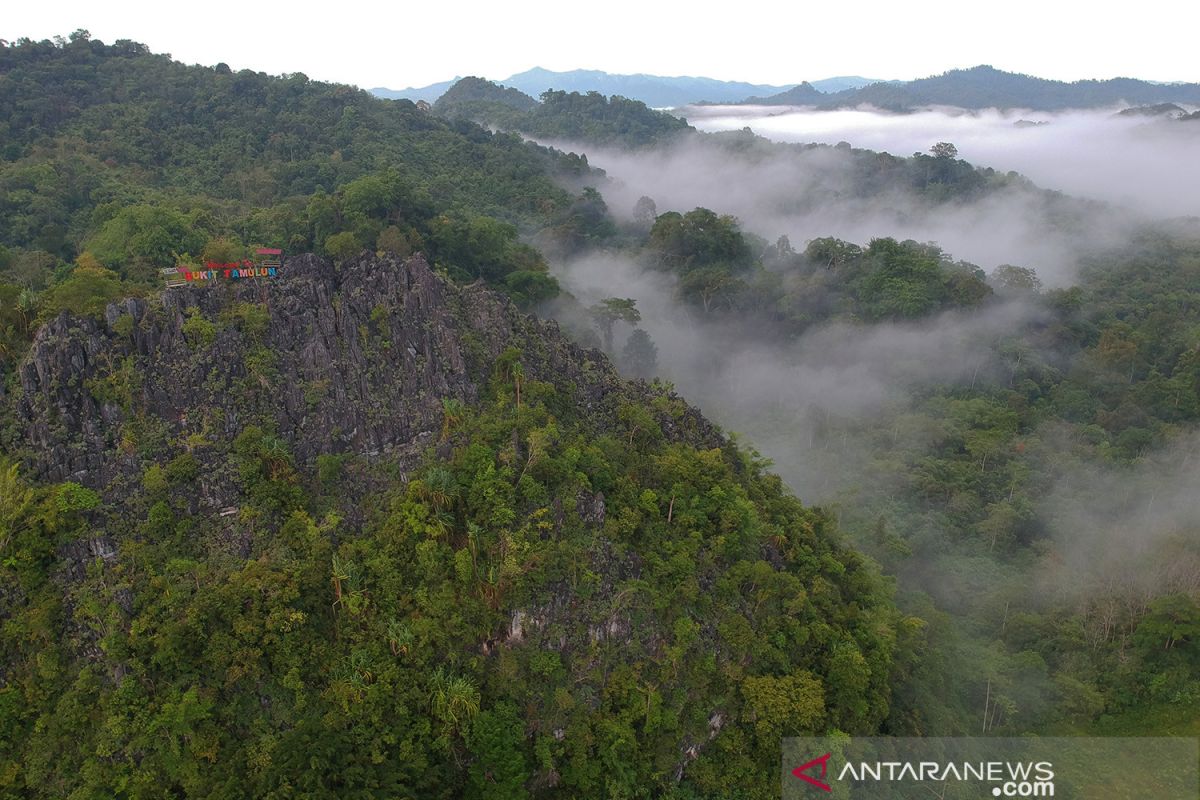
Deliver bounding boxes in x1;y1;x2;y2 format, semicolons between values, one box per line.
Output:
371;67;876;108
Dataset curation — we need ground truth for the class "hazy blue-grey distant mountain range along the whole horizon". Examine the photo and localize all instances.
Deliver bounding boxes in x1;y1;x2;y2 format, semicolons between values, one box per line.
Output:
371;66;1200;112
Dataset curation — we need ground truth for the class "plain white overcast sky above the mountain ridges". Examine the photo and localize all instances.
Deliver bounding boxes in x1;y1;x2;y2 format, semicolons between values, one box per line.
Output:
7;0;1200;88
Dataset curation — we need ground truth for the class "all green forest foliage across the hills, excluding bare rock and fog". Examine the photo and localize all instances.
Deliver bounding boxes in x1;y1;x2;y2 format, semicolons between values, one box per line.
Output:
14;26;1200;796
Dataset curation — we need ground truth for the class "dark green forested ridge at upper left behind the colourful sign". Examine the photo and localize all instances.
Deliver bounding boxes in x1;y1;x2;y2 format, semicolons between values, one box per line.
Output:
0;37;589;307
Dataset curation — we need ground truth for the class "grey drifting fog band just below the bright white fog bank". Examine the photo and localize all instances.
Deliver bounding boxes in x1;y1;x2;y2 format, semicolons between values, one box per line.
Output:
566;139;1104;285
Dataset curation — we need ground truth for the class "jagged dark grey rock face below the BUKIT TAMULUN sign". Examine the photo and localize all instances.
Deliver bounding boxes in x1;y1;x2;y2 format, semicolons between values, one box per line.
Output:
18;254;722;489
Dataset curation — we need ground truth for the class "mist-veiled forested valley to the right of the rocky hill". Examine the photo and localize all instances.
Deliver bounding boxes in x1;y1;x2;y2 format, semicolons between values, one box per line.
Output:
597;214;1200;734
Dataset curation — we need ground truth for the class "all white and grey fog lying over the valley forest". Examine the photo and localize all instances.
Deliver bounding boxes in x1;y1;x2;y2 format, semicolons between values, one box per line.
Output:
547;107;1200;606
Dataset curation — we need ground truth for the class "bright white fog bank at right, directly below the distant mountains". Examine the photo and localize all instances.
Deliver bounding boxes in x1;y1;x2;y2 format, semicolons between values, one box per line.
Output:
683;106;1200;216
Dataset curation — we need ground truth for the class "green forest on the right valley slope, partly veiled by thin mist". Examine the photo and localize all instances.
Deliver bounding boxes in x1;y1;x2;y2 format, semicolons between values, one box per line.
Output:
739;231;1200;734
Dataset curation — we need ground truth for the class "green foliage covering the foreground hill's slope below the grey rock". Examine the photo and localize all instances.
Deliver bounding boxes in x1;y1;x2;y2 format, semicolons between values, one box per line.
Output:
0;304;898;798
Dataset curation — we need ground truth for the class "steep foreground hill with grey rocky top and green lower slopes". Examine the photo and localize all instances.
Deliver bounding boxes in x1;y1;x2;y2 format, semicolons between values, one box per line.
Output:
0;255;918;798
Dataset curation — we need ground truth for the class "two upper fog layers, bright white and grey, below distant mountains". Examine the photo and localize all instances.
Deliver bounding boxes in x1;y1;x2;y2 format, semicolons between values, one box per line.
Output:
551;106;1200;287
